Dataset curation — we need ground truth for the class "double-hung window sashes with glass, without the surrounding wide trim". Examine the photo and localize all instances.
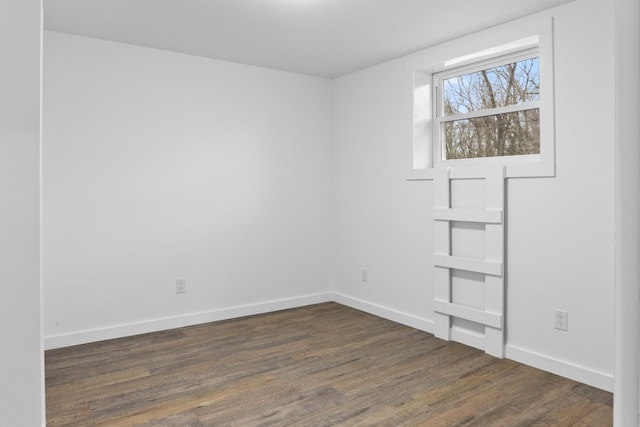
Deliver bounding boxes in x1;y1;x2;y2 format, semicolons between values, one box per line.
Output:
433;50;540;160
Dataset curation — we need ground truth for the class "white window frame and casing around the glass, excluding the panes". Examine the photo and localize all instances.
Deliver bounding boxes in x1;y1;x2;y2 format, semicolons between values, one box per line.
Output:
407;18;555;180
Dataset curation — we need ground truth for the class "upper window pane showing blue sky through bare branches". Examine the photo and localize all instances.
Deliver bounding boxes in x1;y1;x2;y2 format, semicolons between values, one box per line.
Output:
442;57;540;116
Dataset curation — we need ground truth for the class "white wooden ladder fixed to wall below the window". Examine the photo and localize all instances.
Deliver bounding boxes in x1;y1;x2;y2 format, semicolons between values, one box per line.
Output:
433;166;505;358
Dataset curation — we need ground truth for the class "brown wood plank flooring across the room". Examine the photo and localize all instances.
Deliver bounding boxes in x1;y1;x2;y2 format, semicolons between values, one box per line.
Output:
45;303;612;427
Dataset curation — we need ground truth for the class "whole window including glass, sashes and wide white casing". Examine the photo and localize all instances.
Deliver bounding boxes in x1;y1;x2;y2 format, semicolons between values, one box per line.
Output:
408;19;555;179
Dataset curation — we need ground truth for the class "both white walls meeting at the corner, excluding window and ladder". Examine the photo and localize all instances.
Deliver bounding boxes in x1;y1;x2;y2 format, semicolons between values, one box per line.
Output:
44;0;615;396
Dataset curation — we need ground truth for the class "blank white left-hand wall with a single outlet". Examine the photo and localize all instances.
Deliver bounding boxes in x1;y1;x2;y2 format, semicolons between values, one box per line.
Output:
43;31;331;345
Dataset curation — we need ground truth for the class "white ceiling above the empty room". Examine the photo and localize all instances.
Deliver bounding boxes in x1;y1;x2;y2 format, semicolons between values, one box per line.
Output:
44;0;572;78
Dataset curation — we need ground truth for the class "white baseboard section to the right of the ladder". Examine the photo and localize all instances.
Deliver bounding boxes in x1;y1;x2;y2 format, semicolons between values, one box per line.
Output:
505;344;613;392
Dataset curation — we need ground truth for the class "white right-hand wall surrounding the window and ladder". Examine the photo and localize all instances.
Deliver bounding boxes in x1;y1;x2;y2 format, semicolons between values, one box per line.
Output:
333;0;614;389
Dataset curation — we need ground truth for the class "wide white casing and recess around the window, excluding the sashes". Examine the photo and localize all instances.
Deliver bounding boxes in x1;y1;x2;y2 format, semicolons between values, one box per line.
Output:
406;17;556;181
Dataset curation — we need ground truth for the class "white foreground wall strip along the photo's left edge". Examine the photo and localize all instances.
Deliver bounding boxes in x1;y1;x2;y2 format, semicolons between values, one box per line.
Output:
0;0;44;426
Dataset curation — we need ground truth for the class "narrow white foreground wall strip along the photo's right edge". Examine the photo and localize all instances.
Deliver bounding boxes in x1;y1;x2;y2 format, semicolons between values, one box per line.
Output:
613;0;640;427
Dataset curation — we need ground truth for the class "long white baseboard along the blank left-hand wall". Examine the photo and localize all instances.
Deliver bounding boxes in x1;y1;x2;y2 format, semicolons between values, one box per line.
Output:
44;294;333;350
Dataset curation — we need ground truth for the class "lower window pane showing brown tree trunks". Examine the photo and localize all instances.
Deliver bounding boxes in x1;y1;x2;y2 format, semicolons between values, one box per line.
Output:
442;108;540;159
